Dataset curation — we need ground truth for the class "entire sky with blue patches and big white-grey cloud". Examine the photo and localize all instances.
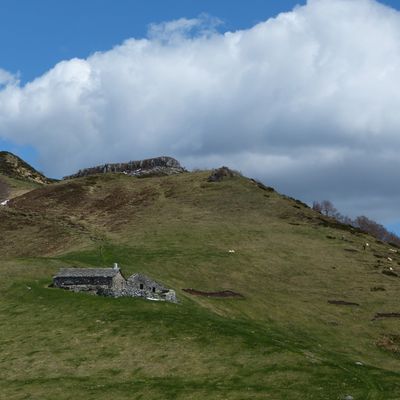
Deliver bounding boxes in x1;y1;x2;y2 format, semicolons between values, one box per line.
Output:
0;0;400;232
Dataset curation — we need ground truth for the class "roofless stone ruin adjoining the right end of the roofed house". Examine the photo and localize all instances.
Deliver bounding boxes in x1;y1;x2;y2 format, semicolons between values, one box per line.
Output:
125;274;176;302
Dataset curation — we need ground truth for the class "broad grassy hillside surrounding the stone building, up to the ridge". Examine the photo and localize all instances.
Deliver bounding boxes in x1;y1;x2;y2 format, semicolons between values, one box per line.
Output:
0;173;400;399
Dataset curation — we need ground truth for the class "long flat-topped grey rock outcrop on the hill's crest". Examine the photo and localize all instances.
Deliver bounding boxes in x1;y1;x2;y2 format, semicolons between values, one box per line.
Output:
64;157;186;179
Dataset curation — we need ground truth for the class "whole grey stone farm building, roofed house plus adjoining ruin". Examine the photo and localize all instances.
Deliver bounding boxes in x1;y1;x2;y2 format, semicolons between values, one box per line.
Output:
53;264;177;303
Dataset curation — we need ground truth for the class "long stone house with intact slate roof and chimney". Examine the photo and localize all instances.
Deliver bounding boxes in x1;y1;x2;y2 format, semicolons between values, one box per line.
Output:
53;265;126;294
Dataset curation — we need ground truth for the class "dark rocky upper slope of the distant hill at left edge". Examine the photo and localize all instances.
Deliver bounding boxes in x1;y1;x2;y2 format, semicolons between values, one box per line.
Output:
0;151;54;184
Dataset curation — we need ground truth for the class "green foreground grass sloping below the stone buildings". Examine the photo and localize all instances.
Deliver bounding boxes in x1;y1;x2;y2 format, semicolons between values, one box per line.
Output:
0;282;399;399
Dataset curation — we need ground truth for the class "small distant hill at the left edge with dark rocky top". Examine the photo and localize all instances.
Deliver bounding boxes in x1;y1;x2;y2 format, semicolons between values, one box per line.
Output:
0;151;54;200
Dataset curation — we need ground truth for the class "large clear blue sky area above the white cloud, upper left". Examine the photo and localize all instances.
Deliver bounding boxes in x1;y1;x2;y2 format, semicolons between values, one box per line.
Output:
0;0;305;81
